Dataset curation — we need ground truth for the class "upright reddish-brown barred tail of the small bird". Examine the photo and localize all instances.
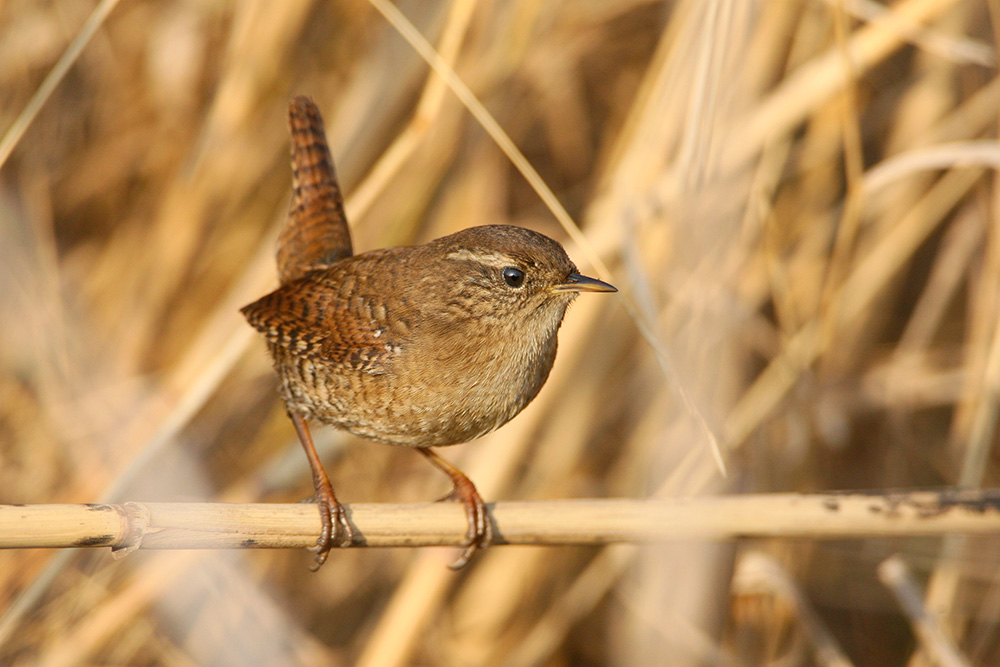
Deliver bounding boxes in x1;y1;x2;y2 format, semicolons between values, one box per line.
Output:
278;95;353;285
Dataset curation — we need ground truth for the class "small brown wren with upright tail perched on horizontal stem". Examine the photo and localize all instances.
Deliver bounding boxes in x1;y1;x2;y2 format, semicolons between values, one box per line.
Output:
241;96;617;569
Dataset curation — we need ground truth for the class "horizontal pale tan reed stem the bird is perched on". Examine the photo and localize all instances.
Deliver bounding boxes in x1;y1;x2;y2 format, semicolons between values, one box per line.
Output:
0;489;1000;556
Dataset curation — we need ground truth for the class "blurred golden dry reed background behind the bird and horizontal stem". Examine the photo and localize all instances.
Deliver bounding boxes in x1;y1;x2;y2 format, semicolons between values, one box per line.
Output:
0;0;1000;667
